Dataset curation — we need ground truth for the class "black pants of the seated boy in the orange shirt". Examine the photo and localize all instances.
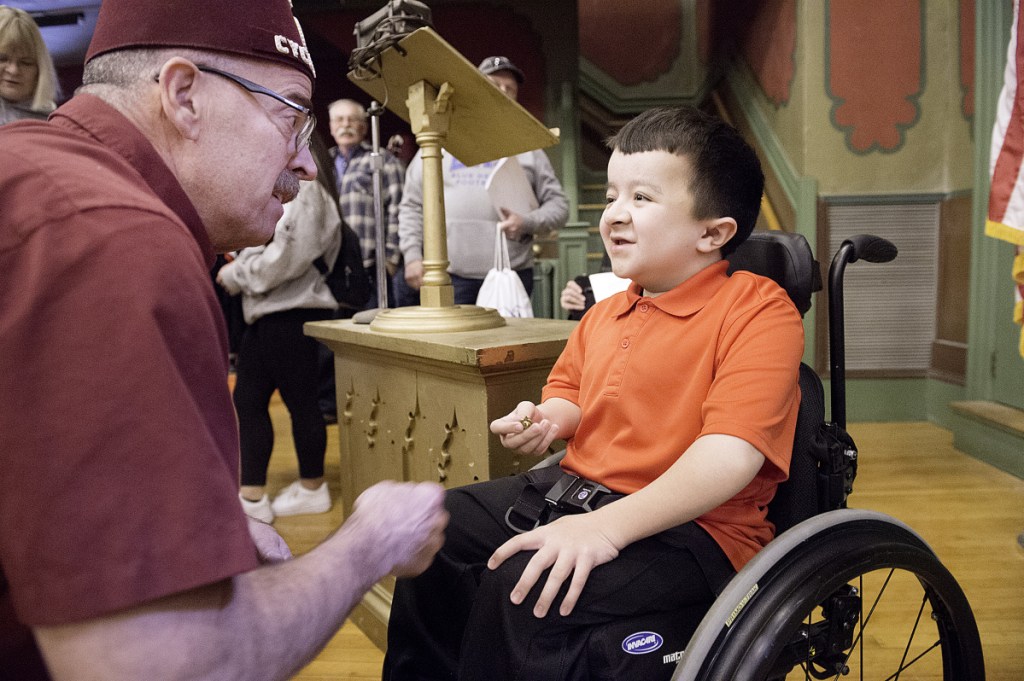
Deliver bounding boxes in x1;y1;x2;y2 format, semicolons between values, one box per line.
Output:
383;466;734;681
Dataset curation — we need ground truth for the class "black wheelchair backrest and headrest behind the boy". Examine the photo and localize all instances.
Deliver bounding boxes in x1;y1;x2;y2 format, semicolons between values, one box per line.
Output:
728;231;856;534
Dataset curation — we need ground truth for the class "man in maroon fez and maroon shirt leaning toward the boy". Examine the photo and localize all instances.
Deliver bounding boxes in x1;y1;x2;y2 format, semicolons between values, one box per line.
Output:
0;0;446;681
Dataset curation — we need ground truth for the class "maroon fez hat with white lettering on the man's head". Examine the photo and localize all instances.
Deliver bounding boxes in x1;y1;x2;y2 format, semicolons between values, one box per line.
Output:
85;0;316;79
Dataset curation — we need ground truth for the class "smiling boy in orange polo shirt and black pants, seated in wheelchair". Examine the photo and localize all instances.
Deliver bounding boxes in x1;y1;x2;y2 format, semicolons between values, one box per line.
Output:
385;103;803;680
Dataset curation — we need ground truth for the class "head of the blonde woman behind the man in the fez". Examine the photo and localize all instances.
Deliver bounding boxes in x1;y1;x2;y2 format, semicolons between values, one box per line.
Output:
0;5;57;125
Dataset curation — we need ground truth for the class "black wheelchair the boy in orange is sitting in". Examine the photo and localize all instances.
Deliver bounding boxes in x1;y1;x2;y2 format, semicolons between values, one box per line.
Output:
561;231;985;681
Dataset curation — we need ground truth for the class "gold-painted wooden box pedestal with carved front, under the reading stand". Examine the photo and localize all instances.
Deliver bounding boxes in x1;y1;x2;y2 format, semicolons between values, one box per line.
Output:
305;320;575;649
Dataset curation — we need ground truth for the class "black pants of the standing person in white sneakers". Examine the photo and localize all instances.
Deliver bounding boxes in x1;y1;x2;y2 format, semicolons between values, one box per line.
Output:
232;308;334;486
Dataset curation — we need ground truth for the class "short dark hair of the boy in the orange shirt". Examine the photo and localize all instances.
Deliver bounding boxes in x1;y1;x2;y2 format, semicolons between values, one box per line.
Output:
607;107;765;255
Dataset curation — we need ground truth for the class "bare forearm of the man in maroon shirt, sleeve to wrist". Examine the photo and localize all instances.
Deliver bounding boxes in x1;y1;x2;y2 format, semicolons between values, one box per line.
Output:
35;517;391;681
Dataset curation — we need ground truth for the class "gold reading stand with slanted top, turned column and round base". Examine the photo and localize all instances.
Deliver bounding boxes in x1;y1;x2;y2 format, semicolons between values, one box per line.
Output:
348;27;558;333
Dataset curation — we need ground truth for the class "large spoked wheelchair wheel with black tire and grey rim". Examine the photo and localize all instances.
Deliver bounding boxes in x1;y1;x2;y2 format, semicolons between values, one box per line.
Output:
673;510;985;681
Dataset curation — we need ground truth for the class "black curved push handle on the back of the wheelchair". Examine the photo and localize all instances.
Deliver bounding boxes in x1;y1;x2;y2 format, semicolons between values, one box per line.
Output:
828;235;899;428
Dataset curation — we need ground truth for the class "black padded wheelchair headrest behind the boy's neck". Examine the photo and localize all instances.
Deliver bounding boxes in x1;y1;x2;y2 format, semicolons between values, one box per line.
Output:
727;231;821;314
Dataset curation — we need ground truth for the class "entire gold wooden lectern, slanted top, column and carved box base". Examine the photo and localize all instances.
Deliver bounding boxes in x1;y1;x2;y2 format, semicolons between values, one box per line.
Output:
305;23;575;649
